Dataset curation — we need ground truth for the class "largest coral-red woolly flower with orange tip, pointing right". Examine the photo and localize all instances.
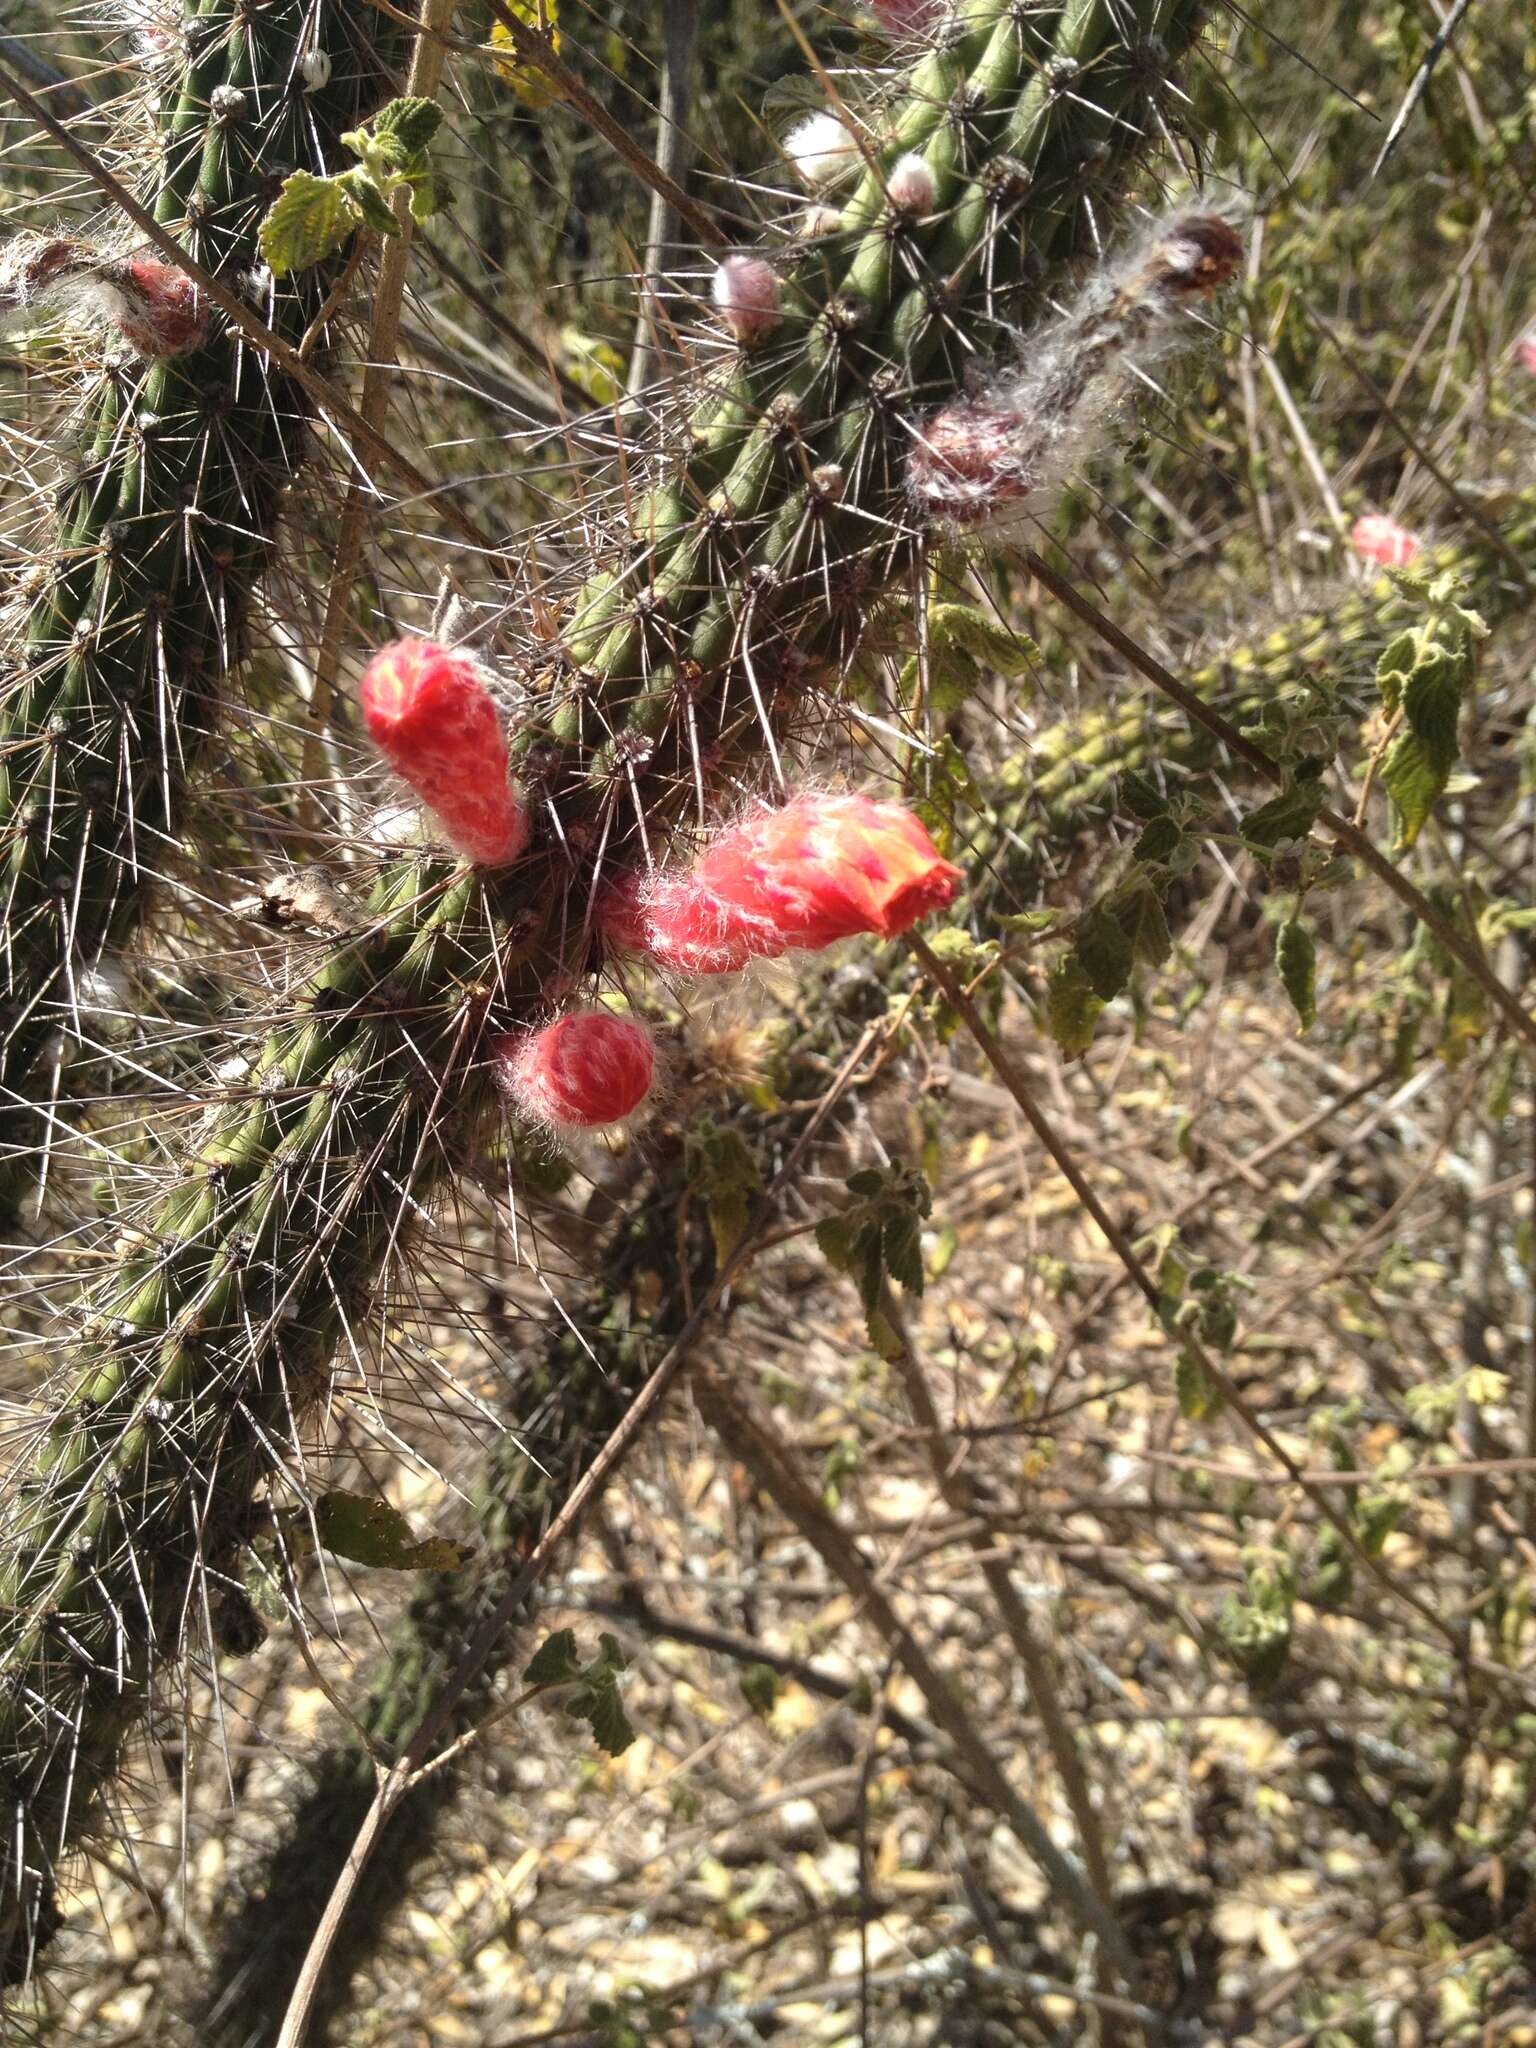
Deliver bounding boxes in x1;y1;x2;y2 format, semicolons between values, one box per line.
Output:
602;795;961;975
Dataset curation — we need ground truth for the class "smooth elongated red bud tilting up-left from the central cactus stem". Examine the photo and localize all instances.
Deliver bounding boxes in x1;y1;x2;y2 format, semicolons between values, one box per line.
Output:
362;639;528;866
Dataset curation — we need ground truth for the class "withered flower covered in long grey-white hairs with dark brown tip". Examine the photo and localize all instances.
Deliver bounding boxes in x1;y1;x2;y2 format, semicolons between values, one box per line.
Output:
907;213;1243;528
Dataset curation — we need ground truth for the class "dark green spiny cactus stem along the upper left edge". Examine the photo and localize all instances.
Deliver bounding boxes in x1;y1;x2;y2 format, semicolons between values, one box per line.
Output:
0;0;391;1217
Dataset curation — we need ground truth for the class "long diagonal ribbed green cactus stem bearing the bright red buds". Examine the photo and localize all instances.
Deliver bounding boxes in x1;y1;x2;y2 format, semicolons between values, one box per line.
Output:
0;0;1196;1978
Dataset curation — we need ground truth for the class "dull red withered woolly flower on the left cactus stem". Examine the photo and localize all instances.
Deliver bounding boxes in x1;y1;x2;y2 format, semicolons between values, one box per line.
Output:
0;236;209;360
